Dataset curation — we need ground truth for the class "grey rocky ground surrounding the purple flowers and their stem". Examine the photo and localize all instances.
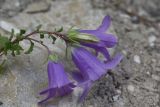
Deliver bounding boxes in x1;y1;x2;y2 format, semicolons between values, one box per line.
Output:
0;0;160;107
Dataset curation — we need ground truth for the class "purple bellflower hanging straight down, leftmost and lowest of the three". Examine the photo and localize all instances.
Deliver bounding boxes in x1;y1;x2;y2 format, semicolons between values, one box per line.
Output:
39;61;75;104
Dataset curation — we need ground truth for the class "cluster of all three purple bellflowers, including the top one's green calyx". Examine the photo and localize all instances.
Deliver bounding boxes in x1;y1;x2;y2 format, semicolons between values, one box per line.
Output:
39;16;122;104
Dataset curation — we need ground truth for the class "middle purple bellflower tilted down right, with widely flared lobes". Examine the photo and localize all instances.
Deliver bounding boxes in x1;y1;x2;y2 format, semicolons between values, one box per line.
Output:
72;48;122;101
